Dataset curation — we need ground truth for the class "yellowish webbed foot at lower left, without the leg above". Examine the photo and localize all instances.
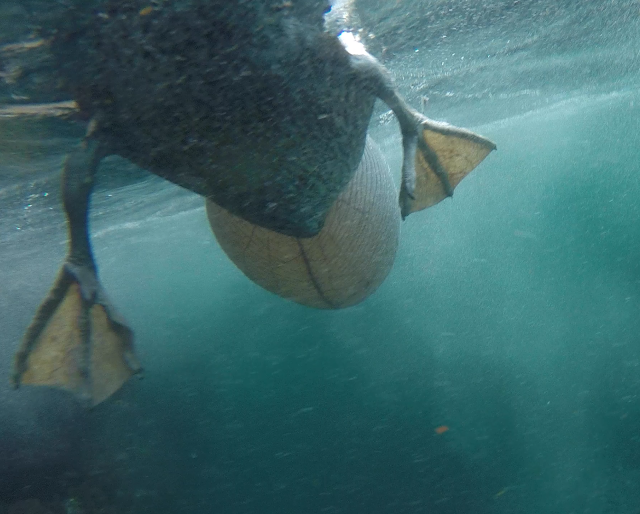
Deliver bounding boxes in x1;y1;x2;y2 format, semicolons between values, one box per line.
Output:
13;263;140;406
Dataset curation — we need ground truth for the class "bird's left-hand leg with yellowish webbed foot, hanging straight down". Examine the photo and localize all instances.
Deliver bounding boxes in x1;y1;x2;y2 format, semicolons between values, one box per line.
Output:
13;125;140;405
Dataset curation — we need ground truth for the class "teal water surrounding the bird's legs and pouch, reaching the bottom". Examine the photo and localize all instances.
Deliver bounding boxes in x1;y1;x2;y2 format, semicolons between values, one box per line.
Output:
0;1;640;514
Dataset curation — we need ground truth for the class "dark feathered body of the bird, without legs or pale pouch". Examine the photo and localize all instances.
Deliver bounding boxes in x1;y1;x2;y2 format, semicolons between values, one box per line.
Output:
52;1;375;236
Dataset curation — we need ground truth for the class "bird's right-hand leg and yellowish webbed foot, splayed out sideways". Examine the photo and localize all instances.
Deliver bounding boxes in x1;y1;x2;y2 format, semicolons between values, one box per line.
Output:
343;40;496;219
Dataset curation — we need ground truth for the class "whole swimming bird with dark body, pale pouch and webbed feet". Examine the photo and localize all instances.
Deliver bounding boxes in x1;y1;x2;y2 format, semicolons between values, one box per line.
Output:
13;0;495;405
